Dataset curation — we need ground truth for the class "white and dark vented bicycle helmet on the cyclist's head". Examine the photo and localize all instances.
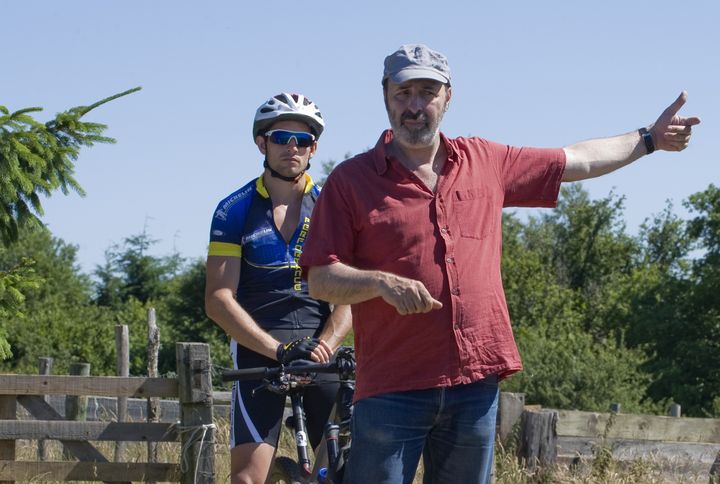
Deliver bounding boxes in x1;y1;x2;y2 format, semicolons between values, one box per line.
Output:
253;92;325;140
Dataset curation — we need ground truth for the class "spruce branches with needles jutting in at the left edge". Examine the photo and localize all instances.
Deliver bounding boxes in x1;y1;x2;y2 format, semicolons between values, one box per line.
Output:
0;87;140;360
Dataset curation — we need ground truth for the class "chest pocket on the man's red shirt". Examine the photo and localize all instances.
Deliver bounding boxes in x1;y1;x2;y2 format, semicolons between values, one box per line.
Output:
453;187;497;240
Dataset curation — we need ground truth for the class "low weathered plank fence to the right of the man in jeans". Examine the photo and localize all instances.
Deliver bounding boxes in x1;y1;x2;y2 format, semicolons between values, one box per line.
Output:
499;394;720;482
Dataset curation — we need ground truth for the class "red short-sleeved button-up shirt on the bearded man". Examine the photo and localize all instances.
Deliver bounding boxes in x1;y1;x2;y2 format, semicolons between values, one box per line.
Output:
300;130;565;400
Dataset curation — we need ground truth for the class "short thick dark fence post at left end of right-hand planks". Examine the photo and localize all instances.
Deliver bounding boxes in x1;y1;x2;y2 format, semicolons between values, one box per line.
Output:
518;410;558;470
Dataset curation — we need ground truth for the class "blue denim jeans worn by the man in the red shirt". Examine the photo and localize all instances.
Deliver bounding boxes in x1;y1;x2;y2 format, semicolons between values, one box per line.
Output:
343;375;498;484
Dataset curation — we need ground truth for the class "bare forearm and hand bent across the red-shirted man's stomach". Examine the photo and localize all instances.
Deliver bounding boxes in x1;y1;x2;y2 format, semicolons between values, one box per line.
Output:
308;262;442;314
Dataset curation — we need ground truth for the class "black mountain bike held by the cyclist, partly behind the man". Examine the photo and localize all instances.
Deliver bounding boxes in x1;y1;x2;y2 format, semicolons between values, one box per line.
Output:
221;346;355;484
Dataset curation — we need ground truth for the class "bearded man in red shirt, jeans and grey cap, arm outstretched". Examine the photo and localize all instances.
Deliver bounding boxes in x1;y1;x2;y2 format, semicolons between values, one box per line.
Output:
300;45;700;483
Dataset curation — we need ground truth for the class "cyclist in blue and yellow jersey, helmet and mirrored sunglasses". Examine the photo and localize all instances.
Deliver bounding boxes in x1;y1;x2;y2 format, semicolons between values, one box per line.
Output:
205;93;350;483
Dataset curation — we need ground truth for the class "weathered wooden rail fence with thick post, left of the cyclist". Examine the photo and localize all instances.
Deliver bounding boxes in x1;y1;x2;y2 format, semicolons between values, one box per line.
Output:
0;343;215;483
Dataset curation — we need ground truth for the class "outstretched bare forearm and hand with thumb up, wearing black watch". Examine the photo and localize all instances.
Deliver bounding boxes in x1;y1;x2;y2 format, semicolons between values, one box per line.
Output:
562;91;700;182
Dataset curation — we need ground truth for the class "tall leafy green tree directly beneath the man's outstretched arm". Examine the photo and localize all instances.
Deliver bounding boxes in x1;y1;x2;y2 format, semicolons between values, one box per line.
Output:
502;185;657;411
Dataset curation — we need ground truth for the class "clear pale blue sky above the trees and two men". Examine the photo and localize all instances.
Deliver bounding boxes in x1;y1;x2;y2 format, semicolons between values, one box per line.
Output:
0;0;720;272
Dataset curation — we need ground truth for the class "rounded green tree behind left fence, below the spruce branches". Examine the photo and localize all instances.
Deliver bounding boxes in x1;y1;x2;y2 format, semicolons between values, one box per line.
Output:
0;227;115;374
